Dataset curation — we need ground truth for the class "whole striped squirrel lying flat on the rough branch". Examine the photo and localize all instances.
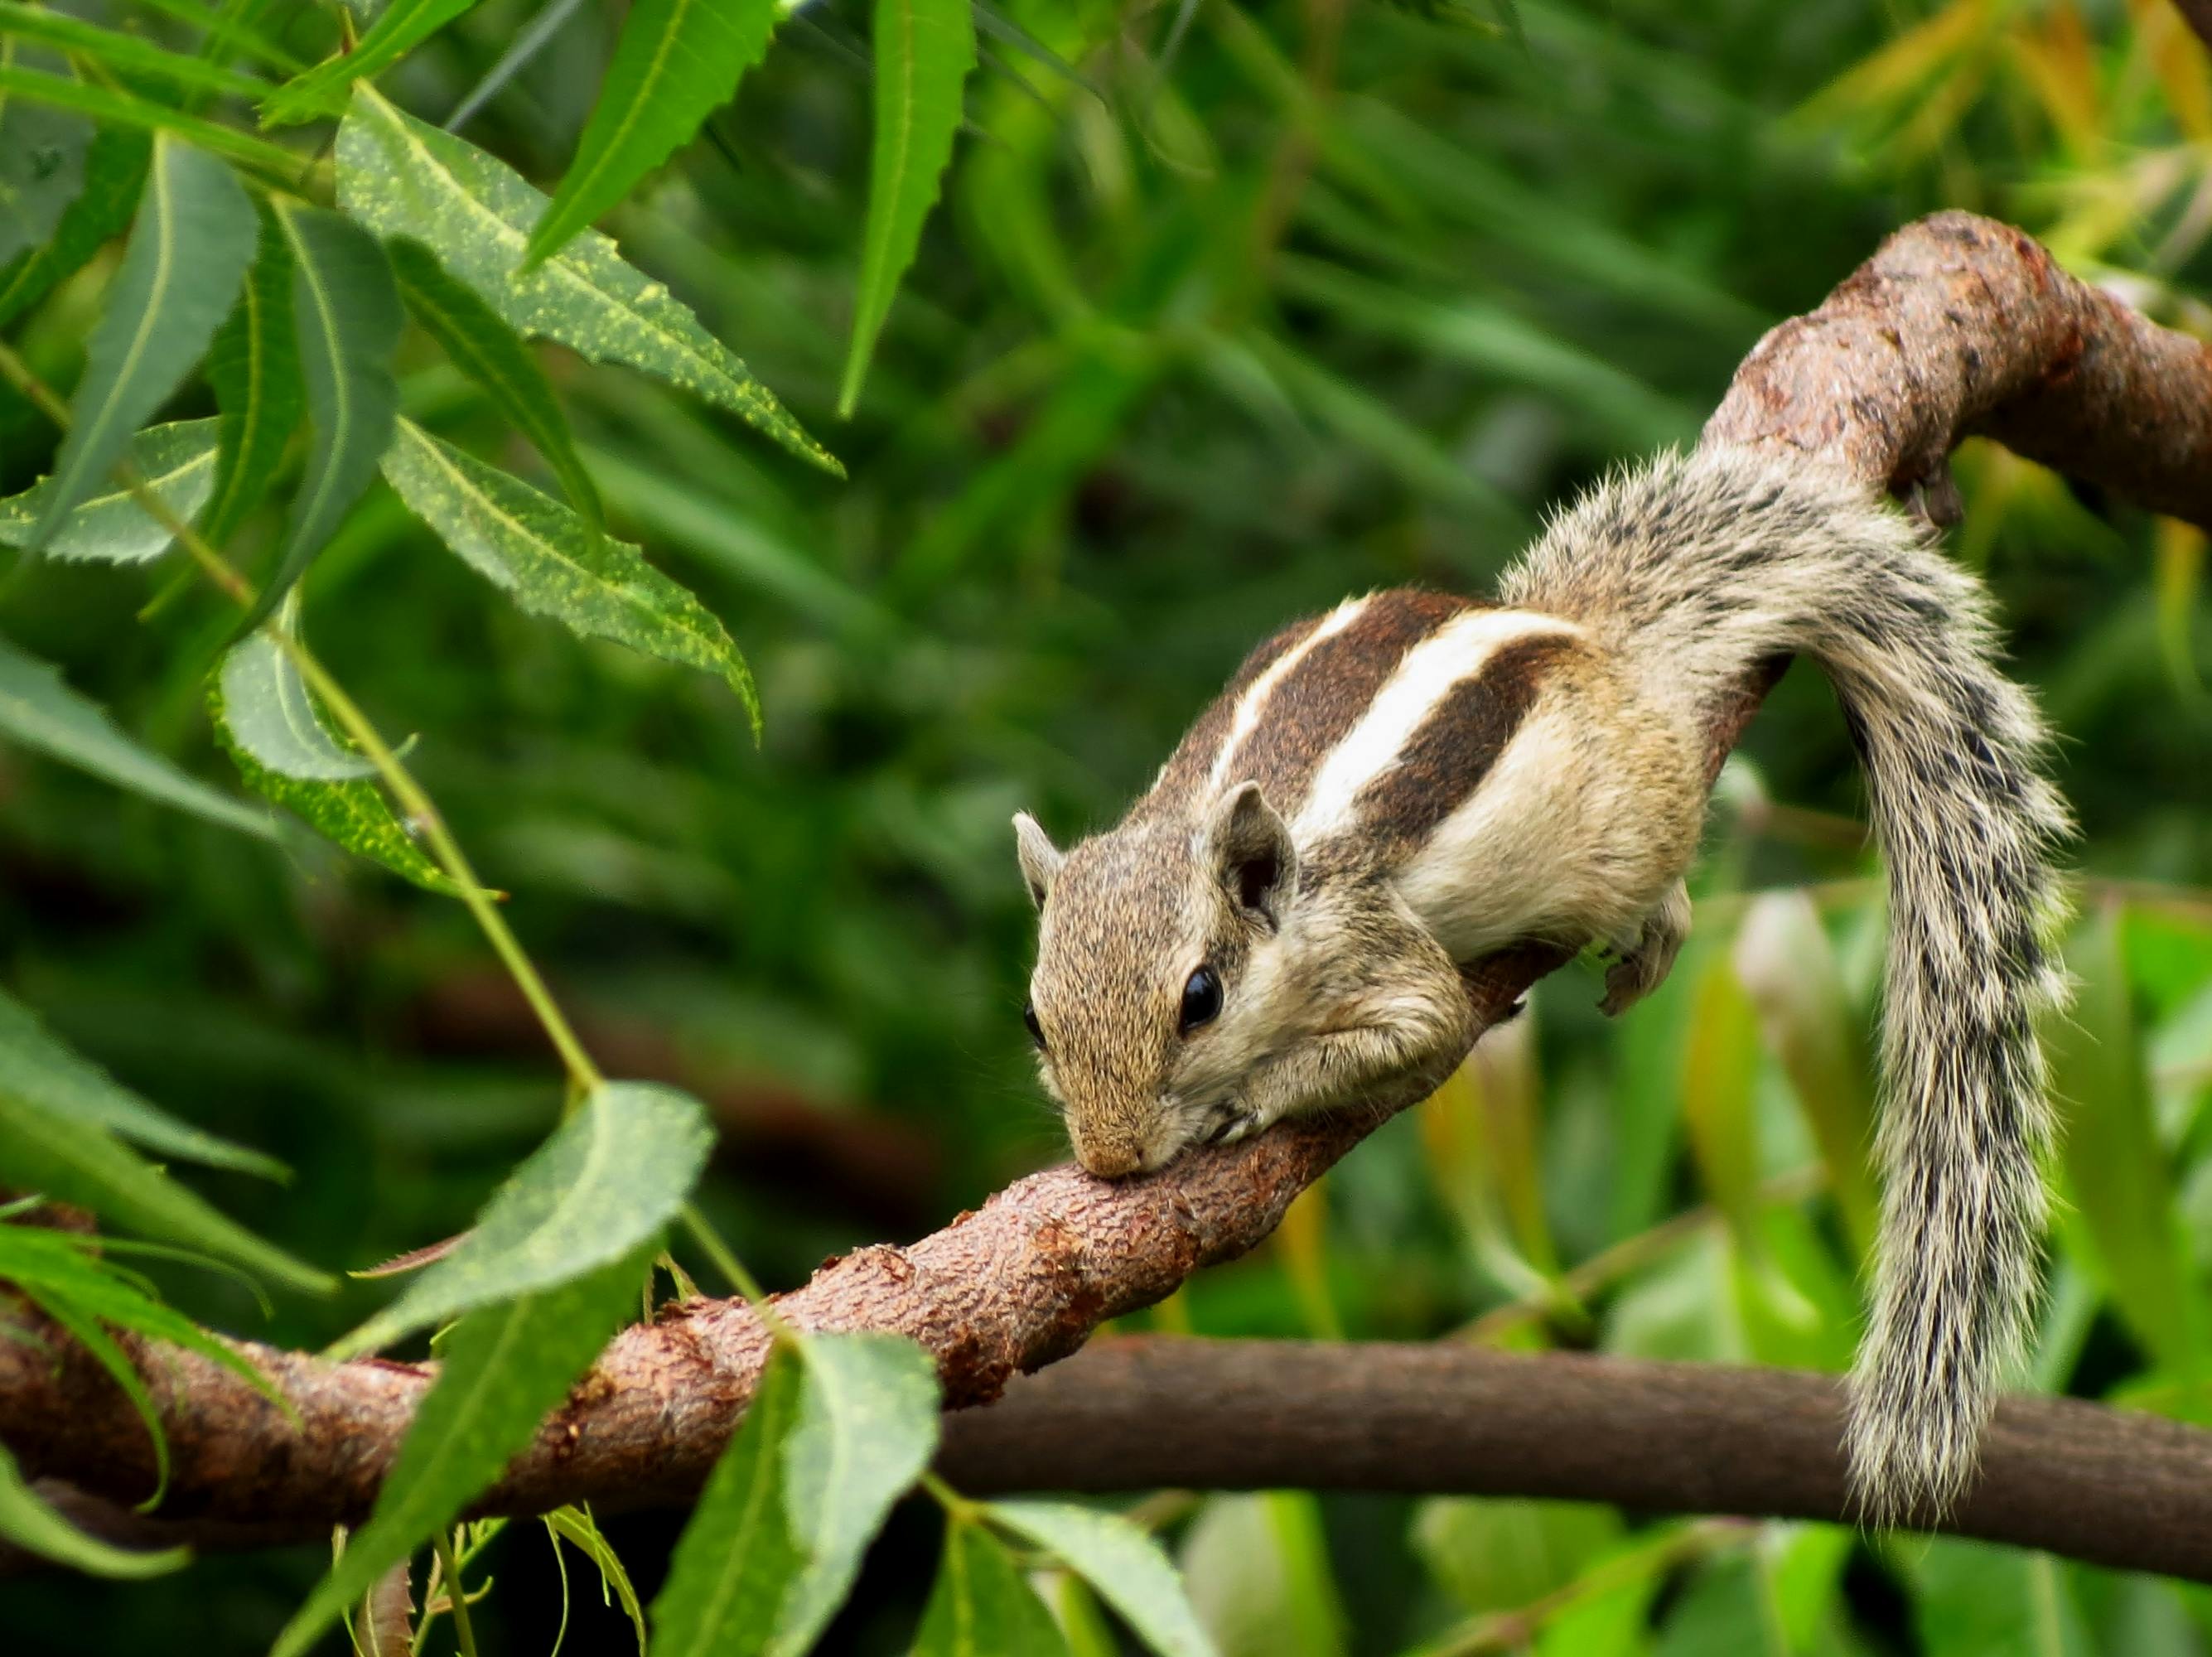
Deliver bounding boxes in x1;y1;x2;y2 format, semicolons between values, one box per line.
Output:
1016;447;2070;1522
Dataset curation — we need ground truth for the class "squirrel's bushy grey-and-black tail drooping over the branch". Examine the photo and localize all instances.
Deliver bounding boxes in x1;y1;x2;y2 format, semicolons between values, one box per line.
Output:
1502;449;2068;1522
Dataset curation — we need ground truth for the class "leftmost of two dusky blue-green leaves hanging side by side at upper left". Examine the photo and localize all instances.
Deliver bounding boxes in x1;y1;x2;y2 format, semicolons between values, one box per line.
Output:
31;133;254;548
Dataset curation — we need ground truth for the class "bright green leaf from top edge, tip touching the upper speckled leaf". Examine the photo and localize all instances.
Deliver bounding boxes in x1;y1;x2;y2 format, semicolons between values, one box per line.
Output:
522;0;783;265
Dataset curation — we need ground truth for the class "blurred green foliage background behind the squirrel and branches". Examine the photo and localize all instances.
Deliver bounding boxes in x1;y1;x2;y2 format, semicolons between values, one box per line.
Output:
0;0;2212;1657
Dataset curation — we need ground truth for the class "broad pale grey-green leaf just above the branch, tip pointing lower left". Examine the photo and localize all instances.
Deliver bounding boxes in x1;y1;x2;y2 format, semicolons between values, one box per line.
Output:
332;1082;714;1356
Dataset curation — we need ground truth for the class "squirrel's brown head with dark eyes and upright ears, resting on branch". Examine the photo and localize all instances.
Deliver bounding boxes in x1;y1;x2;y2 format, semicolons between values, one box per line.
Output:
1013;783;1298;1177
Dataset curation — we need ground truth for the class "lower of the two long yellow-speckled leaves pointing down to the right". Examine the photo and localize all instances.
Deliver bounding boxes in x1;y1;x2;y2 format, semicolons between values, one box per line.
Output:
385;420;761;732
